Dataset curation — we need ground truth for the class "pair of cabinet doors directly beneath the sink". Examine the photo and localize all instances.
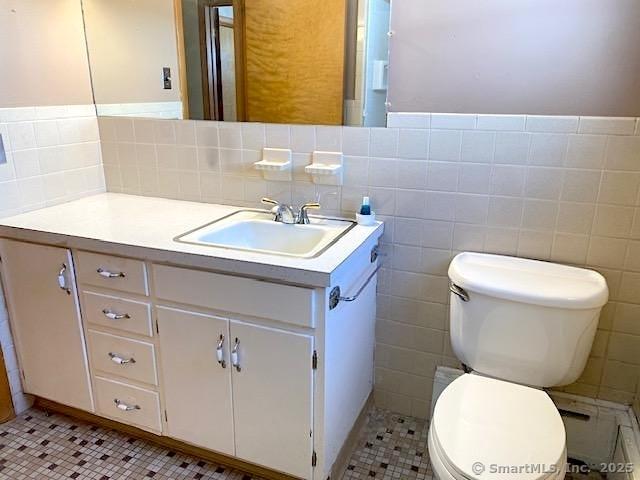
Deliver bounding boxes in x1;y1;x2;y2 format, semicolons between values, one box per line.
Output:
157;306;313;478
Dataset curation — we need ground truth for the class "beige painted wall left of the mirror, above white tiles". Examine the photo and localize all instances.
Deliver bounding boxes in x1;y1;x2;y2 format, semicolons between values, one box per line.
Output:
0;0;93;107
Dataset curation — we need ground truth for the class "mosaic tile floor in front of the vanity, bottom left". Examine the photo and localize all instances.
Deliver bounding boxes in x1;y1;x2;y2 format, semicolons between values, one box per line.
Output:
0;409;259;480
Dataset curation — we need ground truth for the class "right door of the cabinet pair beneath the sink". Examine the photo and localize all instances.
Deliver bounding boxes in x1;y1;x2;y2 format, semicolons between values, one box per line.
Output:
230;320;313;478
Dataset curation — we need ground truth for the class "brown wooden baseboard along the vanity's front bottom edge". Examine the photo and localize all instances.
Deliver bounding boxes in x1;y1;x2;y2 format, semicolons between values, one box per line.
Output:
34;398;302;480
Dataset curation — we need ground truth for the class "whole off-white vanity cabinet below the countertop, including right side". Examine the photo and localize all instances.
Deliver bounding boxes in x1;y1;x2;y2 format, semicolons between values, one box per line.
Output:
0;237;377;480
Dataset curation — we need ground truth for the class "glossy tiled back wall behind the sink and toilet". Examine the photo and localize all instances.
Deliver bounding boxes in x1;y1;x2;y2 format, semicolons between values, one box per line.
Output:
84;113;640;417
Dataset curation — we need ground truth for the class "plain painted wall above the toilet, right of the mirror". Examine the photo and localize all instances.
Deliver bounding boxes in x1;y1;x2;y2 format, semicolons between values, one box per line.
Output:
389;0;640;116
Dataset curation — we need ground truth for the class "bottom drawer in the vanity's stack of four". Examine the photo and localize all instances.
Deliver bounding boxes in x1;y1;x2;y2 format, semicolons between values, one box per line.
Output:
93;377;162;432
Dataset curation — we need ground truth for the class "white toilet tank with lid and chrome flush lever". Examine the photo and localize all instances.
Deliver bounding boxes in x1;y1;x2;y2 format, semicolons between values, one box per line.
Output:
449;252;609;387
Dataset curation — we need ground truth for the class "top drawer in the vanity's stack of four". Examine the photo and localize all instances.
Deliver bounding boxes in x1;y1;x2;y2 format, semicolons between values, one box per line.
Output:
77;252;149;295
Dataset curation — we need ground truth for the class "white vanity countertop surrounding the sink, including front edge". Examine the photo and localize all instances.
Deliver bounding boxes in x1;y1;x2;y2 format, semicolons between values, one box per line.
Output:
0;193;383;287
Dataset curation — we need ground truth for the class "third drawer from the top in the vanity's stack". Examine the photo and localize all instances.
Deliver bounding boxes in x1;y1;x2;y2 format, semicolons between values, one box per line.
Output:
88;330;158;385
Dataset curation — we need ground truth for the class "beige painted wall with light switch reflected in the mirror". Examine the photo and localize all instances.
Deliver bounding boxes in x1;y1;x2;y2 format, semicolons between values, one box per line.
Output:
83;0;180;104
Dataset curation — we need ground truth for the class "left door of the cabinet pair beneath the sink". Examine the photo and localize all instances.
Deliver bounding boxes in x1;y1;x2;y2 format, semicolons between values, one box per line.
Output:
158;307;234;455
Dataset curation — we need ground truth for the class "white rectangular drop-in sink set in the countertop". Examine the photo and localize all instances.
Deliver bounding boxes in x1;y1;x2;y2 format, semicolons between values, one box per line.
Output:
175;210;355;258
